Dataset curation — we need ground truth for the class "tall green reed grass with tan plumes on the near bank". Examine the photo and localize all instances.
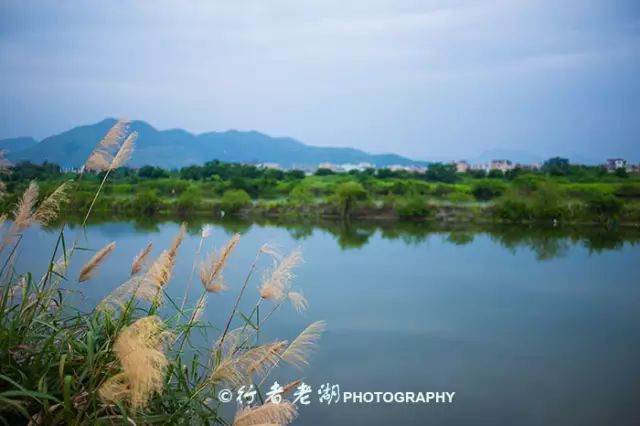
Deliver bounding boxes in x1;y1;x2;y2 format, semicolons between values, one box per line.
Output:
0;121;324;425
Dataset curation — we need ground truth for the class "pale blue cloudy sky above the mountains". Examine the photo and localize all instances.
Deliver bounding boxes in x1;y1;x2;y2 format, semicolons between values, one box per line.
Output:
0;0;640;162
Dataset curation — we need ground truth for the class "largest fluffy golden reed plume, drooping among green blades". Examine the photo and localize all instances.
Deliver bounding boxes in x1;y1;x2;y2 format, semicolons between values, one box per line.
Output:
99;316;172;409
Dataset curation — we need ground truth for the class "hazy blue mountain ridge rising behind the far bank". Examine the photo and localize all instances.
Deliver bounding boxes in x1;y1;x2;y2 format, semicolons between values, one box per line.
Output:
5;118;426;168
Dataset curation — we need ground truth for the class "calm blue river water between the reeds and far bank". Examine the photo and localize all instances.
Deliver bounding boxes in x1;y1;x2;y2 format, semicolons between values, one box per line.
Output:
11;221;640;425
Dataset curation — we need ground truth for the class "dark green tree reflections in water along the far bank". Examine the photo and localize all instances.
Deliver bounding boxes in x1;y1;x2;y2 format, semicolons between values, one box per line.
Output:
52;215;640;260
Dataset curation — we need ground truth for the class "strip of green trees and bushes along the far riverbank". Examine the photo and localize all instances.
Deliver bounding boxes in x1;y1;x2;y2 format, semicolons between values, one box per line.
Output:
1;158;640;224
